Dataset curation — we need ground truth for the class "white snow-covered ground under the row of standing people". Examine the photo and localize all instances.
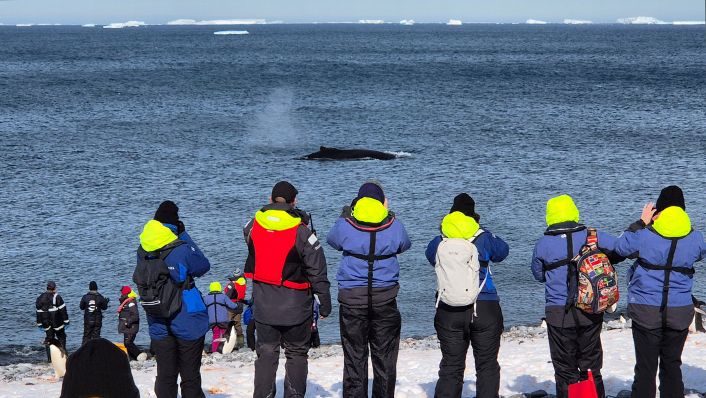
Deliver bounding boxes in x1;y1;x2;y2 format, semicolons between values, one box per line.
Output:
0;328;706;398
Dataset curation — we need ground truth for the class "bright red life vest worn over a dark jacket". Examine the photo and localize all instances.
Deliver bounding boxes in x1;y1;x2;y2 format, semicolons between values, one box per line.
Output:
245;220;311;290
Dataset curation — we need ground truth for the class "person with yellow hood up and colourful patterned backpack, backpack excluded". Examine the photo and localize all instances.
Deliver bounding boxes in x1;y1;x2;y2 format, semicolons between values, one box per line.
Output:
532;195;622;398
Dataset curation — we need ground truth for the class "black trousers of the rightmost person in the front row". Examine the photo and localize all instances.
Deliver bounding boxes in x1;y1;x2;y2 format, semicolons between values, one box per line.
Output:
632;322;689;398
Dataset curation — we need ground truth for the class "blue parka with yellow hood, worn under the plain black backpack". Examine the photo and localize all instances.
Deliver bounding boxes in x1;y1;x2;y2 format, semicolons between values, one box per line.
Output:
140;220;211;340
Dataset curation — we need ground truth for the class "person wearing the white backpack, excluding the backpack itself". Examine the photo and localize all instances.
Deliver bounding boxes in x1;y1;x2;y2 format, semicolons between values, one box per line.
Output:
426;193;510;398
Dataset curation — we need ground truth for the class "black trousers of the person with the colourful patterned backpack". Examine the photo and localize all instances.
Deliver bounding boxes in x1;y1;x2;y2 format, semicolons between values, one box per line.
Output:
547;322;605;398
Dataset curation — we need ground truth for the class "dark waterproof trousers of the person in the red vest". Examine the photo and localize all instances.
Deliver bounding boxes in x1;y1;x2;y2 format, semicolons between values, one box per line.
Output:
252;318;311;398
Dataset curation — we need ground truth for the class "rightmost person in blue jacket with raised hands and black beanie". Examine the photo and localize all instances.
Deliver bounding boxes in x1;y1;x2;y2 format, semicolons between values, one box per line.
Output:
615;185;706;398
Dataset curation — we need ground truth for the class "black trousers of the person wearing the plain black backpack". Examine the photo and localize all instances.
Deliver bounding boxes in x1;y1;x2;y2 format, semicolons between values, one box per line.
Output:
152;336;205;398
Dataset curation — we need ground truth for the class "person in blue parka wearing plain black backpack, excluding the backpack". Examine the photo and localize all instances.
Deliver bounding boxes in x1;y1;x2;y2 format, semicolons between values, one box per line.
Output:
138;201;211;398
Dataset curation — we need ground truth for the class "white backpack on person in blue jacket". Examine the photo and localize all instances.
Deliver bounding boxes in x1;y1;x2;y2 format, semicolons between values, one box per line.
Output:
434;229;490;307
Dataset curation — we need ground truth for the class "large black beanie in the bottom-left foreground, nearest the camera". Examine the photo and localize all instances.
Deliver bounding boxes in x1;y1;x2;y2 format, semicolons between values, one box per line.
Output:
61;338;140;398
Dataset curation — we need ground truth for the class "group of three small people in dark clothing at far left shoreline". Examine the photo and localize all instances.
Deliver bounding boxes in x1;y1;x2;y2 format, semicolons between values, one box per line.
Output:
36;281;142;359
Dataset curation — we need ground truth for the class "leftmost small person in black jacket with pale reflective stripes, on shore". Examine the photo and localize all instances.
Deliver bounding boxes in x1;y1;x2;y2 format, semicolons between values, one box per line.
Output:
36;281;69;350
